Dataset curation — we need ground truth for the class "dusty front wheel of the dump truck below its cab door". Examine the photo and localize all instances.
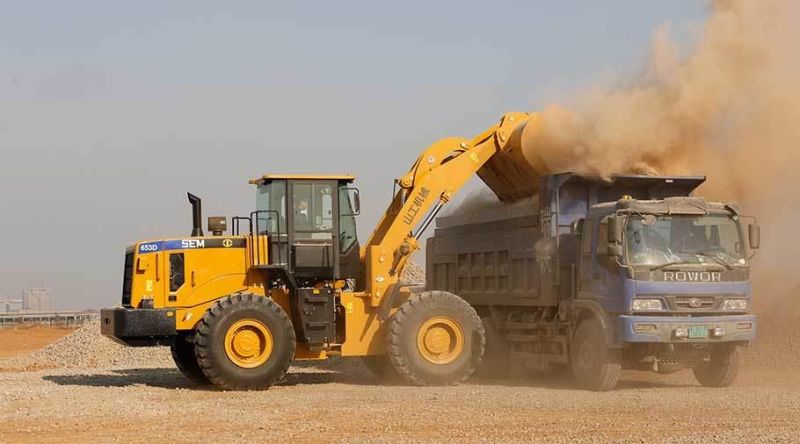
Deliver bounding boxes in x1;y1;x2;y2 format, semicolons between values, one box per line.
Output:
570;319;622;392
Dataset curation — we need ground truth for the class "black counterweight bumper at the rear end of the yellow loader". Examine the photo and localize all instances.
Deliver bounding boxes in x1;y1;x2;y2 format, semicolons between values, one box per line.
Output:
100;307;177;347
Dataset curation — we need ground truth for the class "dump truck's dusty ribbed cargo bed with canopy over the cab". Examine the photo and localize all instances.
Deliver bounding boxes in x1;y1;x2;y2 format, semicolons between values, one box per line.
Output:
426;173;705;307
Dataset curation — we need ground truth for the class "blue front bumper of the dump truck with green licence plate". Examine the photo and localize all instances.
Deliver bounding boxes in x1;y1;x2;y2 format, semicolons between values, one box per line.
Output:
617;315;757;343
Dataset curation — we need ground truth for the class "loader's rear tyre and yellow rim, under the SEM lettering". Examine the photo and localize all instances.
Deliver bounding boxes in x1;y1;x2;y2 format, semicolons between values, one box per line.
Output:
195;294;296;390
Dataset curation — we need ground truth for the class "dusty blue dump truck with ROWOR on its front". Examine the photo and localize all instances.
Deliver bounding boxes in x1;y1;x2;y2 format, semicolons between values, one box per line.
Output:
426;173;760;391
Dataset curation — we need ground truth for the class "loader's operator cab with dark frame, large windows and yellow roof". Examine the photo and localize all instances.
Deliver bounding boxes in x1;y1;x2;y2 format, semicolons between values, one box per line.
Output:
251;175;360;285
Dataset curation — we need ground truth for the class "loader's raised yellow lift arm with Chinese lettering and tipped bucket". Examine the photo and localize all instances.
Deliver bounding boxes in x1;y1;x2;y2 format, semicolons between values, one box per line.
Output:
361;112;538;307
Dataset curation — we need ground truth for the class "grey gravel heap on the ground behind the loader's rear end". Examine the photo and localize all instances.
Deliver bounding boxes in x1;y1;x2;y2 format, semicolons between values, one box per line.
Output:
0;321;174;370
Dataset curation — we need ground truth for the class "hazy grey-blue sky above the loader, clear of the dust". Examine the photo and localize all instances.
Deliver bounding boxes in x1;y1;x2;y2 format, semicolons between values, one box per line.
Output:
0;0;708;309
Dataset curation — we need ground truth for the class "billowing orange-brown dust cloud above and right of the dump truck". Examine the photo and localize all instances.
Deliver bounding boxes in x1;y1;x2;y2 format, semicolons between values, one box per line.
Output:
522;0;800;366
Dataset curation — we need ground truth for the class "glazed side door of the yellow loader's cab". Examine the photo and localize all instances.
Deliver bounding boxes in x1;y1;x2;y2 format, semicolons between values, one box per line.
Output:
289;180;338;280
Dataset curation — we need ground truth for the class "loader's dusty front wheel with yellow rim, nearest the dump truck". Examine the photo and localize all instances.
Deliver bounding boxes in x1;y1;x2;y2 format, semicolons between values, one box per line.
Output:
386;291;486;385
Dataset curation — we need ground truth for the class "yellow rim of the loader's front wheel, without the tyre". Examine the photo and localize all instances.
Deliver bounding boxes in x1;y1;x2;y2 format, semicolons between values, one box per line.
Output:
417;316;464;365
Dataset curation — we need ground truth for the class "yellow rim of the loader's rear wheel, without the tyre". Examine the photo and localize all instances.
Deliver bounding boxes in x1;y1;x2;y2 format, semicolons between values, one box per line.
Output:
225;319;273;368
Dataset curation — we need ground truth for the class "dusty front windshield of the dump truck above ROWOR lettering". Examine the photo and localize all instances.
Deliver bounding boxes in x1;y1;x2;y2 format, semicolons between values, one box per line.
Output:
625;214;745;267
